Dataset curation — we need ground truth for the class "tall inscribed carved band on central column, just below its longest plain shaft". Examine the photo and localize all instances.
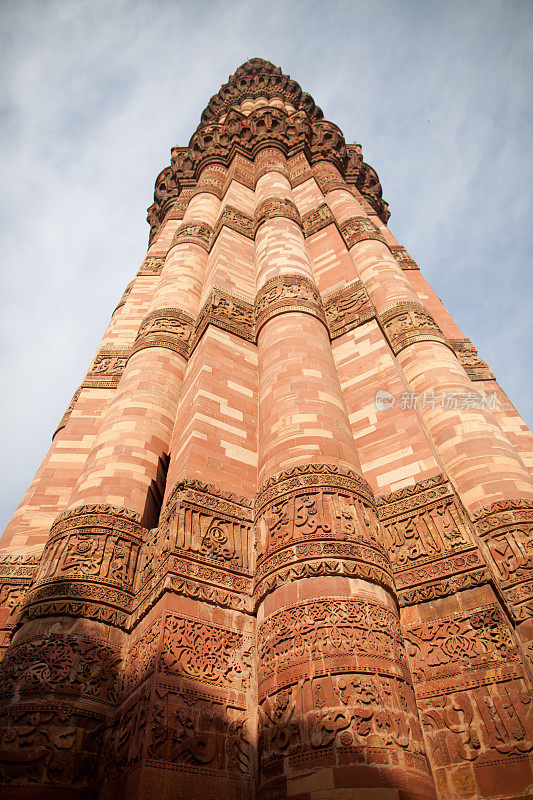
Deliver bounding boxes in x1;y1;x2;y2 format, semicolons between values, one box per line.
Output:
255;465;392;600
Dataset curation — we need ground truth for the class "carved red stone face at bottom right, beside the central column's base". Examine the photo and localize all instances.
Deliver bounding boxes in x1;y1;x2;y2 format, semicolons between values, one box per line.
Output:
403;603;533;798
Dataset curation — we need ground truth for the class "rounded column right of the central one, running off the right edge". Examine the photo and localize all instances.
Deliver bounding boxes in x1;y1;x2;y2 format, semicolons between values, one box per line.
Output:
315;162;533;642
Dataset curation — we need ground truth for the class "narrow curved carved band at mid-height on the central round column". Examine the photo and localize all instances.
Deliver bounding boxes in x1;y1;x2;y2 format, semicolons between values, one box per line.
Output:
255;275;327;334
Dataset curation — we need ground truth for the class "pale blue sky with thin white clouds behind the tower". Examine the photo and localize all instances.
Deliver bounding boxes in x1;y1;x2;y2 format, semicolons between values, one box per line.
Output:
0;0;533;530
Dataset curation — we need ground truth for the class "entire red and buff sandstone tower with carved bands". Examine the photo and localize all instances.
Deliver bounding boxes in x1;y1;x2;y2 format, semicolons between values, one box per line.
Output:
0;59;533;800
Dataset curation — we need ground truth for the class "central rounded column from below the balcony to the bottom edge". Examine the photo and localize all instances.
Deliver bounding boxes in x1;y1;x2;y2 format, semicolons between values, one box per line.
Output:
251;150;434;798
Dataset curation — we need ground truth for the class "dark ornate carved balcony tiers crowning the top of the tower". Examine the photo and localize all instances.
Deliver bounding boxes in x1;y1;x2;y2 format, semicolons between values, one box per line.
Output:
147;58;390;241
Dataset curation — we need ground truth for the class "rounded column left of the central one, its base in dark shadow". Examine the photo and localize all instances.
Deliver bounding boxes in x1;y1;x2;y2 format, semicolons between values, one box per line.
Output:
2;167;220;798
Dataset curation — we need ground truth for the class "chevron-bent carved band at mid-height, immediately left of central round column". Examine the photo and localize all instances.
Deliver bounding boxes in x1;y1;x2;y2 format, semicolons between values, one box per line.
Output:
190;286;255;355
